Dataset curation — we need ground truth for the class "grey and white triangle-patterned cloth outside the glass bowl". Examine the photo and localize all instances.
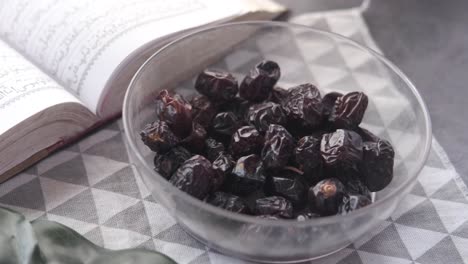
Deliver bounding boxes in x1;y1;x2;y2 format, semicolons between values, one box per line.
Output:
0;7;468;264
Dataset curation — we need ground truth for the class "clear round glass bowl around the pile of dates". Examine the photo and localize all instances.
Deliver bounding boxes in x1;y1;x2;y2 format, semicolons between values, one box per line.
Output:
123;21;431;262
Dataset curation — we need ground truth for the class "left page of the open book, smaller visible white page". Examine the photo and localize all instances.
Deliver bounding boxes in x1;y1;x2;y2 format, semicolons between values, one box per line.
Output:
0;41;79;135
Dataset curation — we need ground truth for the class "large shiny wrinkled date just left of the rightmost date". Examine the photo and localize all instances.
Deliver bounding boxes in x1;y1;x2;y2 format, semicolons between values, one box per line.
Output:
320;129;362;168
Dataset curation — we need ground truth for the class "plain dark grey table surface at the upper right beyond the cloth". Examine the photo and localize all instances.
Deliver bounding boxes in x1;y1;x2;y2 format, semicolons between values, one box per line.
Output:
278;0;468;184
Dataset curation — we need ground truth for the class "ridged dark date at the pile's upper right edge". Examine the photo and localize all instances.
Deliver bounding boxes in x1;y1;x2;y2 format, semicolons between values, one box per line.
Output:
329;92;369;129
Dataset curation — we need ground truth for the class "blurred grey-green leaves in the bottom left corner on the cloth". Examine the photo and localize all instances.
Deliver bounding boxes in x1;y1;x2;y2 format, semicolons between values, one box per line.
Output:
0;207;176;264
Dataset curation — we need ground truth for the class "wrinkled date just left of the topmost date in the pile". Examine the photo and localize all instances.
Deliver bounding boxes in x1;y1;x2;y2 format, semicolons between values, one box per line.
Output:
195;69;239;101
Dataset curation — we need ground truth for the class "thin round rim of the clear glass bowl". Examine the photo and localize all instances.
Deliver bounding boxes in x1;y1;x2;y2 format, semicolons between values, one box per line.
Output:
122;20;432;227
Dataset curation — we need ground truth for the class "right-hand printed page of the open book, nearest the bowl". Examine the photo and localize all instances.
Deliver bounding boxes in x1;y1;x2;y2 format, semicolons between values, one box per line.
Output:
0;0;252;112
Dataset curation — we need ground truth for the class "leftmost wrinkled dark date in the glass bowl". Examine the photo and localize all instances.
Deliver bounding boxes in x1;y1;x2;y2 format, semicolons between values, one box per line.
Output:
140;121;180;153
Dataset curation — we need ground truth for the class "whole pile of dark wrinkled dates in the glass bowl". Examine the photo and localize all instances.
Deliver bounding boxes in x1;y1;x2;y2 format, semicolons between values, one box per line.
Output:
140;60;395;221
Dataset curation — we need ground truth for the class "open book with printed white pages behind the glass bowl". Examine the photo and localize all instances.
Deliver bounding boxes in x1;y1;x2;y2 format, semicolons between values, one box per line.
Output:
0;0;284;182
